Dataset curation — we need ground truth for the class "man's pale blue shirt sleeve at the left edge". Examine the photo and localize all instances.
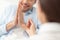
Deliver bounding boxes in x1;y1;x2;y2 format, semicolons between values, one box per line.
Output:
0;6;15;36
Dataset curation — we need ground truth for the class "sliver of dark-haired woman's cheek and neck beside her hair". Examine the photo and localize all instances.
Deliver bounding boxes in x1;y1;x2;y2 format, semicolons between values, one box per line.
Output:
37;2;47;23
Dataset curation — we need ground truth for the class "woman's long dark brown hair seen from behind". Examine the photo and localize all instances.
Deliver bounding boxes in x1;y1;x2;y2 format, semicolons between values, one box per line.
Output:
39;0;60;23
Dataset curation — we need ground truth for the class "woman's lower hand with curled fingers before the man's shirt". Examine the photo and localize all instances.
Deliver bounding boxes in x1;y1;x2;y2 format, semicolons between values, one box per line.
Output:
26;19;36;36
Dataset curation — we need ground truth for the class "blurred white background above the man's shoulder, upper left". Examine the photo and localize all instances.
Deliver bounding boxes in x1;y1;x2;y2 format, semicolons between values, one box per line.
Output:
0;0;35;14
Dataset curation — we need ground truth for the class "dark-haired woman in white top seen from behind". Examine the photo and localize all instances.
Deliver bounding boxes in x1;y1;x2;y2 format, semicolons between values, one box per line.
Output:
26;0;60;40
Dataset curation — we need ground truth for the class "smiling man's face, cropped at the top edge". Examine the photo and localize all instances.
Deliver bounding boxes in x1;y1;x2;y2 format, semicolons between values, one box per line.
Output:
20;0;36;12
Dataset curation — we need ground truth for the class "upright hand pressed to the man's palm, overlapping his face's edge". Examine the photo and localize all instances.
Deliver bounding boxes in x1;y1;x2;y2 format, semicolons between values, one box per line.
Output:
17;2;25;28
